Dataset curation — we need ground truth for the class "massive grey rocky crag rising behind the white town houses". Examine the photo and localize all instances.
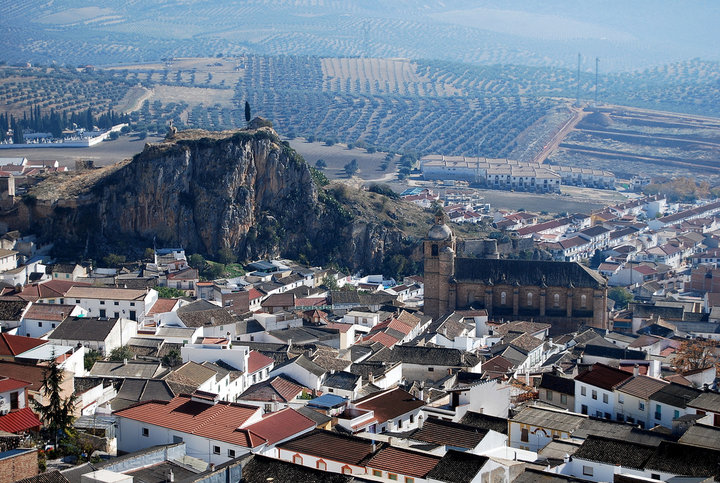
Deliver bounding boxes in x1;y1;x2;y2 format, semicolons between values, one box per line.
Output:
26;127;416;270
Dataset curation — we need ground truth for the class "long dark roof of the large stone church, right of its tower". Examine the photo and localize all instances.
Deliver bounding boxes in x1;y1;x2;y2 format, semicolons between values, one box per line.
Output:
455;258;605;288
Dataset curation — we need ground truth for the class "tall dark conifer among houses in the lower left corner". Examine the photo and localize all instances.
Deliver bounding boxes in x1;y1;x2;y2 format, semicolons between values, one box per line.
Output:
32;353;77;447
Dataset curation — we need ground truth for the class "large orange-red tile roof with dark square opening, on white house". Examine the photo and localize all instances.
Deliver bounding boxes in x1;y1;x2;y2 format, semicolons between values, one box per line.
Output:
113;395;265;448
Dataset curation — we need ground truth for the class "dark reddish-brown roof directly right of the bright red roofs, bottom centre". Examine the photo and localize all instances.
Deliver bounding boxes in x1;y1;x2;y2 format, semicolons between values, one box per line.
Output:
278;429;373;465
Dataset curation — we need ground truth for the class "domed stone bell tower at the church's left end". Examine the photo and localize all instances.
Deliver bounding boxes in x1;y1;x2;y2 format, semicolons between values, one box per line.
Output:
424;208;456;317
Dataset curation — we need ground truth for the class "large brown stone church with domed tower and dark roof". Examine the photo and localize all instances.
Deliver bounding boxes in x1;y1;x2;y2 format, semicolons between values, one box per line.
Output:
423;214;608;333
